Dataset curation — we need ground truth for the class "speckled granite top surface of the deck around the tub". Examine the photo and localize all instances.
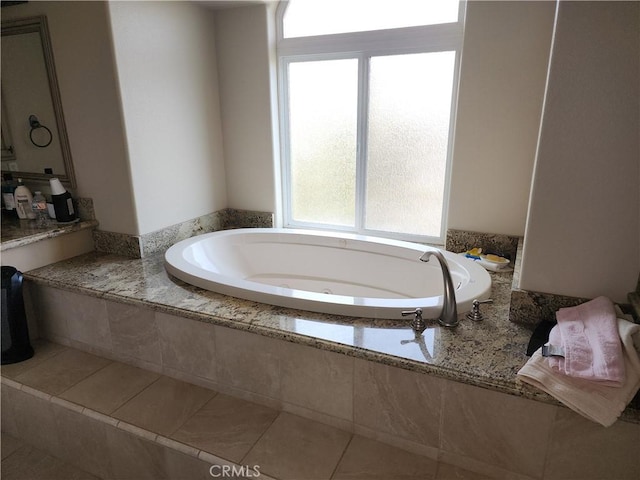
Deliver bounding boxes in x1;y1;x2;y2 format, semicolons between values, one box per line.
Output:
25;252;640;422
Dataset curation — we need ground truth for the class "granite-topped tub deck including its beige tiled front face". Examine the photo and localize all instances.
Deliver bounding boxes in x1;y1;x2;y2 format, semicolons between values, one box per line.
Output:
15;252;640;479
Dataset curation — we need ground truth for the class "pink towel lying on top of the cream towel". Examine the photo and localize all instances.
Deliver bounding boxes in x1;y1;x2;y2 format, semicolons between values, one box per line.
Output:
549;297;625;387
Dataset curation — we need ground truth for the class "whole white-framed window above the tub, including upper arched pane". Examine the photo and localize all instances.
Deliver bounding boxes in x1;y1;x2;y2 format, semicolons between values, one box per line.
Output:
278;0;464;243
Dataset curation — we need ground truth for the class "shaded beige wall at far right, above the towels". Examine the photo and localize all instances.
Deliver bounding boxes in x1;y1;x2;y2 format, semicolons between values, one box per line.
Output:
520;2;640;301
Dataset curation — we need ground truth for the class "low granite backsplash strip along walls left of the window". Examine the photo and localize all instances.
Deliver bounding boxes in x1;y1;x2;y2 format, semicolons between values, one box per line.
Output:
94;208;274;258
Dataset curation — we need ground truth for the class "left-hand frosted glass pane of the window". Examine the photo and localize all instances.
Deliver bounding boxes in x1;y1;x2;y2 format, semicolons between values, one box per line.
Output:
289;59;358;226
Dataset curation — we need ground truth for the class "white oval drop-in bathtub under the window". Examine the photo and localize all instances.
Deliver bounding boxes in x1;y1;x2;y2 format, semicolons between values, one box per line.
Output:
165;228;491;320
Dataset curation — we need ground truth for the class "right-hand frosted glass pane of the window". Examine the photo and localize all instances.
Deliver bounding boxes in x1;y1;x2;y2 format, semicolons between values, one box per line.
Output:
365;52;455;236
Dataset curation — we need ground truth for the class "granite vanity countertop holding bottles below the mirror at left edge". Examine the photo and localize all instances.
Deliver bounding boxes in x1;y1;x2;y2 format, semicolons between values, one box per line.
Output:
0;212;98;251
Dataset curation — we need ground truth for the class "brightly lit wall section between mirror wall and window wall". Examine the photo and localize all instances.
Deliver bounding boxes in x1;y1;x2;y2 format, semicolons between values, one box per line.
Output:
109;1;227;234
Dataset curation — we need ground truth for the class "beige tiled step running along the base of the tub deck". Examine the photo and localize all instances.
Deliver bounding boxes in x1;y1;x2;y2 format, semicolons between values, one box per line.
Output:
1;342;486;480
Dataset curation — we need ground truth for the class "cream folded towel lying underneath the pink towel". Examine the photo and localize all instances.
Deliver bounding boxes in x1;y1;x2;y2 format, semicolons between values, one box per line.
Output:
517;318;640;427
